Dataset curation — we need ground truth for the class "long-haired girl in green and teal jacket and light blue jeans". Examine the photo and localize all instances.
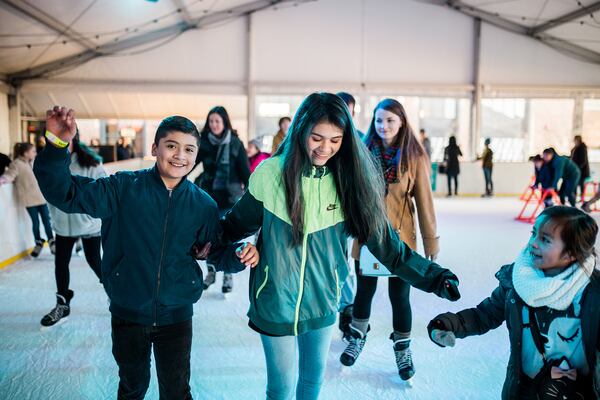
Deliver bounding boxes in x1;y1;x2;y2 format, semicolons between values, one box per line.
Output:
222;93;460;399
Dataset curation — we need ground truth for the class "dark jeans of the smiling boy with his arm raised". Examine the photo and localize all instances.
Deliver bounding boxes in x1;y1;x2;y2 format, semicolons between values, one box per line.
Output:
112;316;192;400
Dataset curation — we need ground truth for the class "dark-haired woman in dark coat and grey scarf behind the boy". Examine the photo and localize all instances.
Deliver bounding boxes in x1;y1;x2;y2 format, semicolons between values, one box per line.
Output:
195;106;250;293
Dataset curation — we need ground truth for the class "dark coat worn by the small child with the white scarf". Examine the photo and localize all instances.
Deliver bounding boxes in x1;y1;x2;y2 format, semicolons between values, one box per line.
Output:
435;264;600;400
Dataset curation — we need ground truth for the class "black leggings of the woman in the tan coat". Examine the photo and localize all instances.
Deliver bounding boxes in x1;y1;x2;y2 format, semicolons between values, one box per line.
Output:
352;261;412;333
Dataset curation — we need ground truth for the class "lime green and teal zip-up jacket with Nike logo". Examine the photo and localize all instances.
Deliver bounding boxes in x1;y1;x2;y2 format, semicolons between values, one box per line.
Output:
222;157;457;335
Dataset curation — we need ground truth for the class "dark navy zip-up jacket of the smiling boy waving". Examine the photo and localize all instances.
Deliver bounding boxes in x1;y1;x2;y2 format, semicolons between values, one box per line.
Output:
34;145;244;326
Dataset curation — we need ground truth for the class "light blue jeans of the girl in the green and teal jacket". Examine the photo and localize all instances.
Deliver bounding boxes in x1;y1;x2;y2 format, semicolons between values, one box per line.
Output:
260;325;333;400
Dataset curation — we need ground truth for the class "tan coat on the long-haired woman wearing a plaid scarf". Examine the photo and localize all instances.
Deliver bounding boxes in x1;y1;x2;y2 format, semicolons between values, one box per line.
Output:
352;155;440;259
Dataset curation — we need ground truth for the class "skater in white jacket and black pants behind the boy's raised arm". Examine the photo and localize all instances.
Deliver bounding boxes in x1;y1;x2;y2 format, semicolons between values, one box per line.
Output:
41;135;107;326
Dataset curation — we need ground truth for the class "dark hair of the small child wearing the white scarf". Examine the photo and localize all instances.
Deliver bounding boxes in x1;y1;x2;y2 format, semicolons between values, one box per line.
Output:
540;206;598;266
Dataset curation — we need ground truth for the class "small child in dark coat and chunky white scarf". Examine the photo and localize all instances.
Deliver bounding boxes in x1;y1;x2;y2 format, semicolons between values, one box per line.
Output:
428;206;600;400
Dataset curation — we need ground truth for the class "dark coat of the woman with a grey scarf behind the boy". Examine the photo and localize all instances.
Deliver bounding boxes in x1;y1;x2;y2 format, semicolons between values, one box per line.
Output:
195;132;250;210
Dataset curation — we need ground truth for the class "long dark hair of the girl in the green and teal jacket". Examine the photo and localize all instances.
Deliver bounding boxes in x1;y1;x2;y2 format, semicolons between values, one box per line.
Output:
275;93;387;243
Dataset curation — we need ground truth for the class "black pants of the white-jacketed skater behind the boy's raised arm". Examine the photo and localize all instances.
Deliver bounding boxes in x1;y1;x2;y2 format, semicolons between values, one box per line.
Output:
54;235;102;296
